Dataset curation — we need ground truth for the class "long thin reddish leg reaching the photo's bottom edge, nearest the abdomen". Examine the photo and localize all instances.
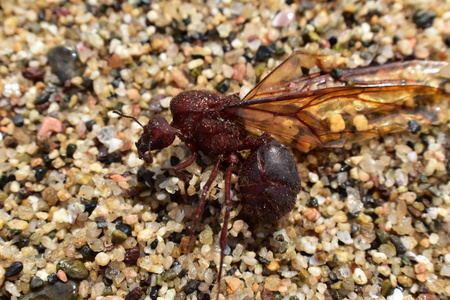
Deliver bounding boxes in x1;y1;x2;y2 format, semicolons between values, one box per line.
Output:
216;164;233;300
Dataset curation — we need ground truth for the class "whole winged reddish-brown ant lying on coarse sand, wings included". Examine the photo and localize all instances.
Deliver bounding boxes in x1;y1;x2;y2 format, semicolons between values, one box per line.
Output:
117;52;449;298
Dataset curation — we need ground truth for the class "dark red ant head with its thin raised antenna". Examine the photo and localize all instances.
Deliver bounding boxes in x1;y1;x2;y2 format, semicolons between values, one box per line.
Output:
114;111;175;163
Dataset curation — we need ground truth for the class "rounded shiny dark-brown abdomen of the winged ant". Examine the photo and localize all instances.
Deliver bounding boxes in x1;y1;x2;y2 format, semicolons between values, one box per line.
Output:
239;139;301;222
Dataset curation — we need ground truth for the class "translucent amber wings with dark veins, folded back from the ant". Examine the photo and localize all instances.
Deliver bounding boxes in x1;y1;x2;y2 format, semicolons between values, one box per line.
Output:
227;52;450;152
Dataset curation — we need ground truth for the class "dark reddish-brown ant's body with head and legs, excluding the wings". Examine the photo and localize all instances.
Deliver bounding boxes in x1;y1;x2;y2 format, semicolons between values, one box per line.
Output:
115;90;300;298
